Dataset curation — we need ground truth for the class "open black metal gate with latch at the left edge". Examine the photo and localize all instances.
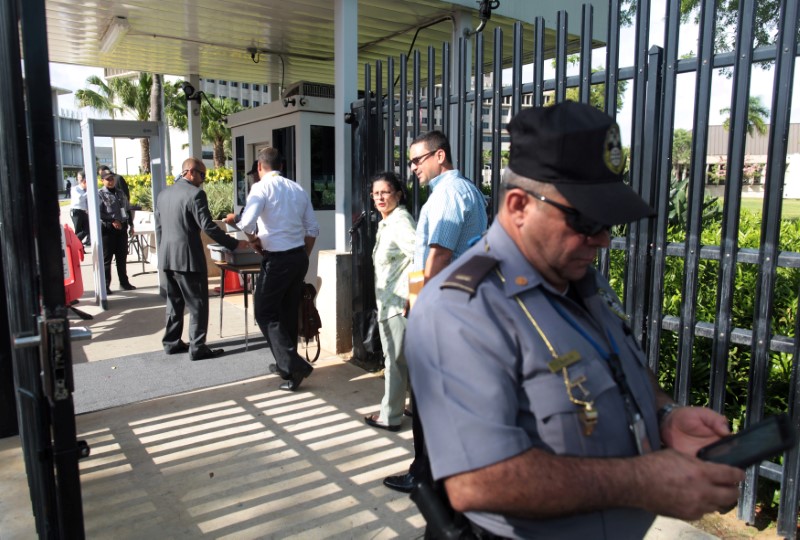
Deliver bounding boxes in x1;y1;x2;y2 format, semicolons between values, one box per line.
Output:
0;0;88;539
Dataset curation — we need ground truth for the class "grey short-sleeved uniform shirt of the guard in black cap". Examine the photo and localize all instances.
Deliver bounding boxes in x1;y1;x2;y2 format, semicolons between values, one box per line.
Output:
405;222;661;539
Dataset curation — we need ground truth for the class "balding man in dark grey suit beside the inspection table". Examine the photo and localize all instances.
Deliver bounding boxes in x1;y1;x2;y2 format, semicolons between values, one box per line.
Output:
155;158;248;360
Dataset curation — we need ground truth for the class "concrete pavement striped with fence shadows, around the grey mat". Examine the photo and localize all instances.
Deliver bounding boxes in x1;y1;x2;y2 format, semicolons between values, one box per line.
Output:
0;210;714;540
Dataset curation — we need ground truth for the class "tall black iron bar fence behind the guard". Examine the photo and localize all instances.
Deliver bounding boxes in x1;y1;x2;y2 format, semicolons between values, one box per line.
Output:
353;0;800;537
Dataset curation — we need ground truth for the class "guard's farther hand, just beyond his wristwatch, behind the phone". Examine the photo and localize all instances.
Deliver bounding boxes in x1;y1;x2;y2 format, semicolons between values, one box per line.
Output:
661;407;731;456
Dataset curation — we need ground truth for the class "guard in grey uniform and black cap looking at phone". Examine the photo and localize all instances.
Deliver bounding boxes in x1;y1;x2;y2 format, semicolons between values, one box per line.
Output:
405;102;743;539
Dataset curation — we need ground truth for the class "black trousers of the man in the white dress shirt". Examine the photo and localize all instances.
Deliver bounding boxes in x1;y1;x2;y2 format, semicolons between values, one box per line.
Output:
253;246;309;379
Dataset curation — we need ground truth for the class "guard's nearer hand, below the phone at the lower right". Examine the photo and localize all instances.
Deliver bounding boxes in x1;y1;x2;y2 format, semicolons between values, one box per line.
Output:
631;449;744;520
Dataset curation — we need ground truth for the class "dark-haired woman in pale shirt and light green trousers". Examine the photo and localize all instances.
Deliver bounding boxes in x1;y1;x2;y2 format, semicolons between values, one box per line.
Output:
364;171;416;431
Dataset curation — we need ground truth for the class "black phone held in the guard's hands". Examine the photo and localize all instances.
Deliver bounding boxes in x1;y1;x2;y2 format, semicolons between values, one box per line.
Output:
697;414;797;469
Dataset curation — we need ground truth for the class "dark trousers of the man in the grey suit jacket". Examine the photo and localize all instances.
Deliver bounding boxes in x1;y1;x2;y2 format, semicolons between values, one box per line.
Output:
161;270;208;354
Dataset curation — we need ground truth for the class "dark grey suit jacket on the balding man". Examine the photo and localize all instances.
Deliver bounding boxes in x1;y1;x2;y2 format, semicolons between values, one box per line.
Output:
155;177;239;274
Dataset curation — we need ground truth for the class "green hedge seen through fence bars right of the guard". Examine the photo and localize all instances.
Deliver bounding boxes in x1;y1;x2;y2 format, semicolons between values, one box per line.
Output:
610;194;800;512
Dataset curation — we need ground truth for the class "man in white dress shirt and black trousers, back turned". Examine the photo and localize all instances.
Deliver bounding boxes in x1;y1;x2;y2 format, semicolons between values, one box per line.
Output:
239;147;319;392
